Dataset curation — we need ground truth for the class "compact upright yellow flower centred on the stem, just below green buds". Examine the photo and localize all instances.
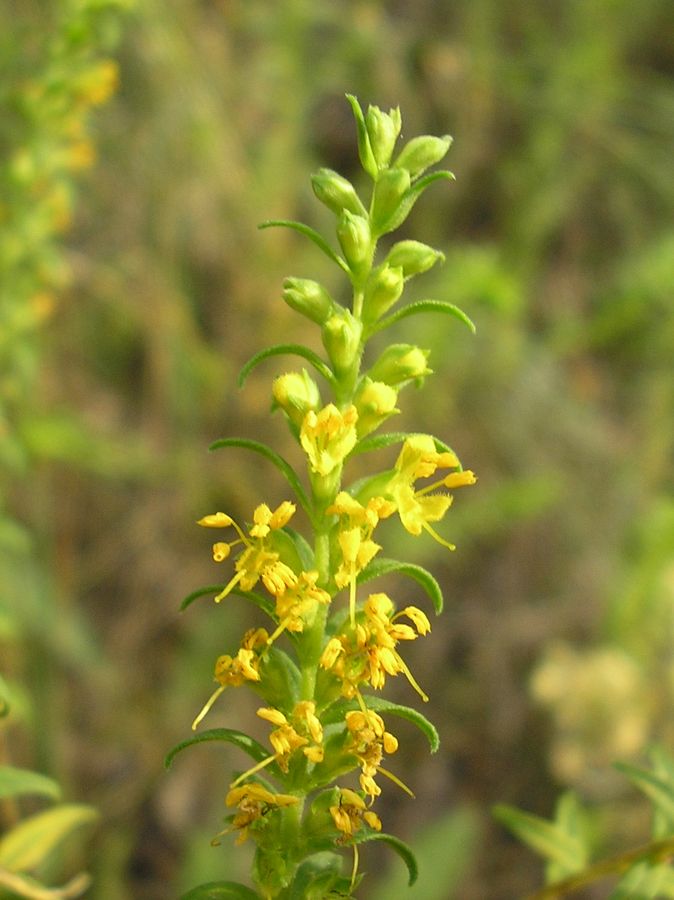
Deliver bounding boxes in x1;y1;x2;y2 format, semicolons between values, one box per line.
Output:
300;403;358;476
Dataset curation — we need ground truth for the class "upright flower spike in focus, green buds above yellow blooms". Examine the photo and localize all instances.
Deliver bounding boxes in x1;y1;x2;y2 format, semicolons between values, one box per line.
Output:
167;96;475;900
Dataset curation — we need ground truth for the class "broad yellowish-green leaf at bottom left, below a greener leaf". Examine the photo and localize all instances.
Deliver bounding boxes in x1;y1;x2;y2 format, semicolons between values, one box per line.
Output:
0;803;98;872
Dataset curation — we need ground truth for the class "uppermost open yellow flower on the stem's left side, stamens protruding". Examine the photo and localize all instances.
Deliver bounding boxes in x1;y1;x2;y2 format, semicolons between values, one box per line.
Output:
197;500;297;603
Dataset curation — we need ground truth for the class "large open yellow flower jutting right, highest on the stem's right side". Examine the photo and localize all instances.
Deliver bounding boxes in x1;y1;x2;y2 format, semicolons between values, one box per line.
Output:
388;434;476;550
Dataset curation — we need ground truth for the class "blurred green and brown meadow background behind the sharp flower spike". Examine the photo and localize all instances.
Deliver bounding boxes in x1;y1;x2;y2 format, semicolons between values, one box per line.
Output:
0;0;674;900
